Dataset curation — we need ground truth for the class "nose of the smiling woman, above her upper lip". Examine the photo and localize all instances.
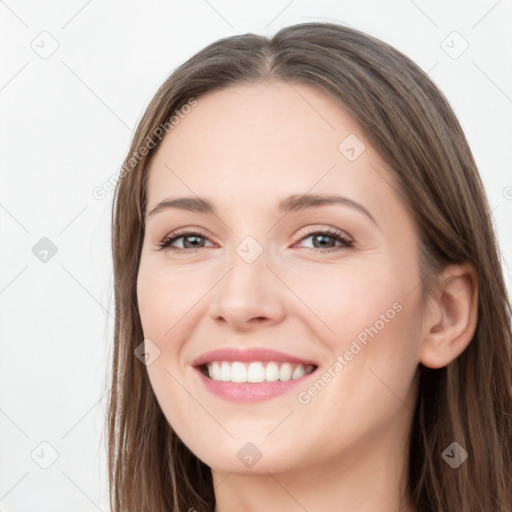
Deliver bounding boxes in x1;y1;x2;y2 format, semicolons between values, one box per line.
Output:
210;247;285;331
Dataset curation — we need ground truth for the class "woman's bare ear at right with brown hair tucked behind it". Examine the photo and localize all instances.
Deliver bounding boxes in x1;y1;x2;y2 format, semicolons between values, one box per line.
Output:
419;263;478;368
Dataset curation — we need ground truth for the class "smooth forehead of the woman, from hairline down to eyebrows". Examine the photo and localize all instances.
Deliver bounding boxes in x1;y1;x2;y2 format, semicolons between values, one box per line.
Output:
147;81;392;214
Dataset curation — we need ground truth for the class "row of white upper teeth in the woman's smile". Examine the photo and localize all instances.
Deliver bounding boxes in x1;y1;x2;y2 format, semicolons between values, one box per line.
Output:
202;361;314;383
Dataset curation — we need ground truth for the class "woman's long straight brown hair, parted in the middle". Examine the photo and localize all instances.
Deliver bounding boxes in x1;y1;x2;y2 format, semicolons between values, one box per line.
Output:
106;22;512;512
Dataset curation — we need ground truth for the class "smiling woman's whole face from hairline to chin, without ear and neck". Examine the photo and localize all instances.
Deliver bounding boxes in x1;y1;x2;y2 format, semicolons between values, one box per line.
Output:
137;82;422;474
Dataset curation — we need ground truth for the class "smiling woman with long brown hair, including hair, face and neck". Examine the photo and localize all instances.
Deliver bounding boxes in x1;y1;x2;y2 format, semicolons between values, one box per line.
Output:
108;23;512;512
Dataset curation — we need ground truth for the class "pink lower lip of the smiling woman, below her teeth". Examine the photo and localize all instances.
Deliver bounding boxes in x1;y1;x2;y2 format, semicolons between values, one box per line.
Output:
194;367;316;402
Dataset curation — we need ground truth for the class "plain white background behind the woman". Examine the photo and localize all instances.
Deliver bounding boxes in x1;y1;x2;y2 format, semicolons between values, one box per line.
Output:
0;0;512;512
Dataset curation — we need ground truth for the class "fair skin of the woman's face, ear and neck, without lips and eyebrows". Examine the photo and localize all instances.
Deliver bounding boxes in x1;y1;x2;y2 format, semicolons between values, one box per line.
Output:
137;81;477;512
